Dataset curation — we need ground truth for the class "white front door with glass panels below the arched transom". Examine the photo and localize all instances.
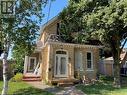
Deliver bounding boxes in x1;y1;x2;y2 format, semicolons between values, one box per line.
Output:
54;54;68;77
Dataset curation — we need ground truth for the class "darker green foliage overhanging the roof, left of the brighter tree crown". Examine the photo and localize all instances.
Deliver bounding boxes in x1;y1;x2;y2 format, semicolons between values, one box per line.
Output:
60;0;109;43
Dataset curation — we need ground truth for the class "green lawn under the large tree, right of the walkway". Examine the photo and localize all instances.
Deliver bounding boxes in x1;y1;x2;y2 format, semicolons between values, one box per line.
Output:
76;83;127;95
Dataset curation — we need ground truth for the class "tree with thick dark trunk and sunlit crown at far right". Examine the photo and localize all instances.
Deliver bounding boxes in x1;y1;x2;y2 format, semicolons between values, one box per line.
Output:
87;0;127;87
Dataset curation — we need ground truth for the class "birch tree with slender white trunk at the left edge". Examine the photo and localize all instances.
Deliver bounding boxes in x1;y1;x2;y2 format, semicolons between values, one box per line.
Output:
0;0;48;95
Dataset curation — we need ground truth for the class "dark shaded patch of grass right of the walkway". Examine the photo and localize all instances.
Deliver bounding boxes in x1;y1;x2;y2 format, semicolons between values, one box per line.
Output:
76;83;116;95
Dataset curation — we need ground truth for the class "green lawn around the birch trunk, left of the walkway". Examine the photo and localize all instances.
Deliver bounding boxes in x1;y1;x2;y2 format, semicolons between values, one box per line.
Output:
0;81;53;95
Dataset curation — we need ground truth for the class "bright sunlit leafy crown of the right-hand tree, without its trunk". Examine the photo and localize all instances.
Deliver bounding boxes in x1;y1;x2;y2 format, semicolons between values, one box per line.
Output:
87;0;127;45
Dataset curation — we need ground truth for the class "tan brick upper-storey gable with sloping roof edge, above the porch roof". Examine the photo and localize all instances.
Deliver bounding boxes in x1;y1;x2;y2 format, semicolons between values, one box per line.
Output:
39;17;60;44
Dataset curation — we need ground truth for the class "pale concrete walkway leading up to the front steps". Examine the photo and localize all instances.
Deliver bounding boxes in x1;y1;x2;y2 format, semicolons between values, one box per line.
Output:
27;82;86;95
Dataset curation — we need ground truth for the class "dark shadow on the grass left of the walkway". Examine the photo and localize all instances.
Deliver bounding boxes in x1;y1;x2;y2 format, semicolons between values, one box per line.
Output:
13;87;53;95
